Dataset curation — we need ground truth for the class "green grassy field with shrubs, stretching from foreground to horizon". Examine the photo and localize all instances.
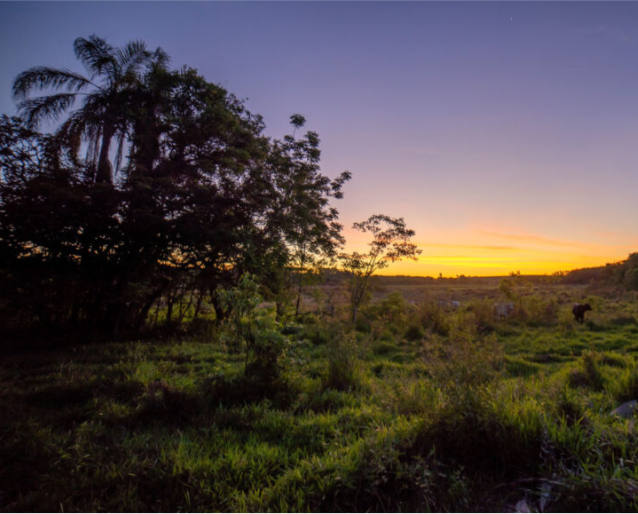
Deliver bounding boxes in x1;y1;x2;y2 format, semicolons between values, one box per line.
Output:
0;281;638;512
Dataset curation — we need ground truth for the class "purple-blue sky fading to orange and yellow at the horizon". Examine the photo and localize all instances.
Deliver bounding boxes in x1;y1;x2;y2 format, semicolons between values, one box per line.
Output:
0;1;638;276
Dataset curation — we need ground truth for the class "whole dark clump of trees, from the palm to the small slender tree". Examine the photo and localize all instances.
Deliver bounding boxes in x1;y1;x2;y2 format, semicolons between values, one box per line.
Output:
0;35;420;336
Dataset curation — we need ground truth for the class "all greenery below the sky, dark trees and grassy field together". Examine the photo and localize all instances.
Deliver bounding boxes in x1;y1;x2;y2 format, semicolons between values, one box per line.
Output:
0;36;638;512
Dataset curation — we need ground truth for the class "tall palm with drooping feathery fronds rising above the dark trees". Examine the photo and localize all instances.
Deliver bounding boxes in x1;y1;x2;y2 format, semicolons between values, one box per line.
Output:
13;35;168;184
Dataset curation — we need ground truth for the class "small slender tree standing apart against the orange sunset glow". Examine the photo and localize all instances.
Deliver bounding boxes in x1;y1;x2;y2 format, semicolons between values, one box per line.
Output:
339;214;421;323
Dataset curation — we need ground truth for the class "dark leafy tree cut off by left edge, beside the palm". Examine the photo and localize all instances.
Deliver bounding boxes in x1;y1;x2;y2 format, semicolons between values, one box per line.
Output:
0;116;97;326
